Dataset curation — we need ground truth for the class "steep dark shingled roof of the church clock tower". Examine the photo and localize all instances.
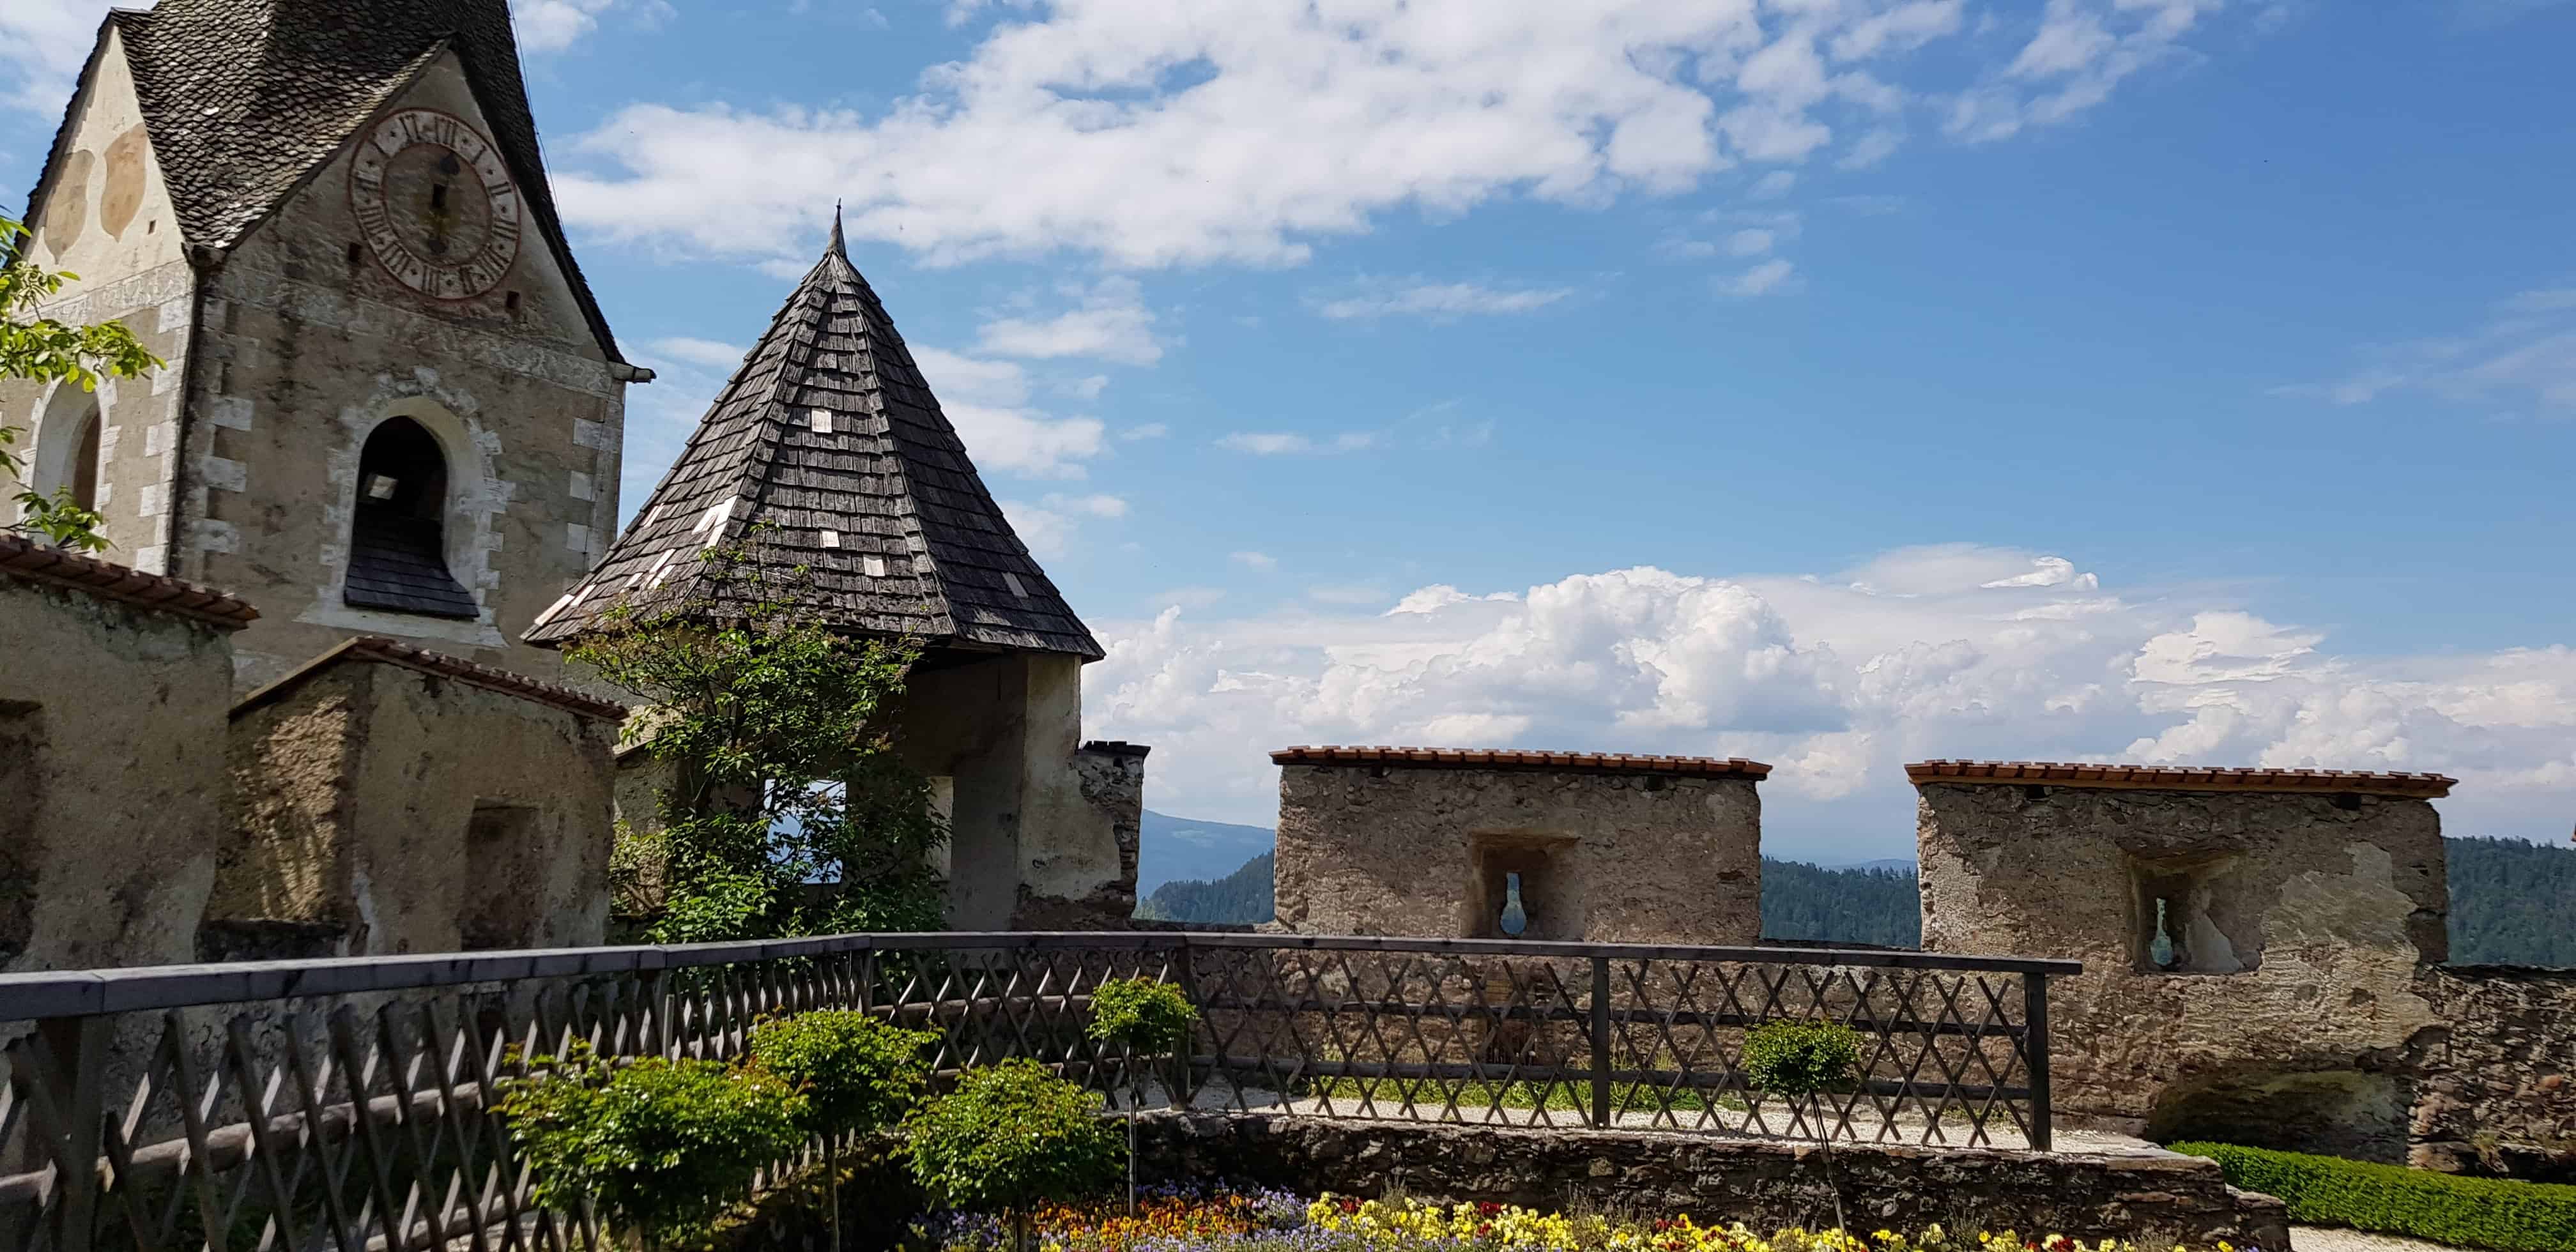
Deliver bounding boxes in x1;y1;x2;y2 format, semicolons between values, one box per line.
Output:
28;0;618;358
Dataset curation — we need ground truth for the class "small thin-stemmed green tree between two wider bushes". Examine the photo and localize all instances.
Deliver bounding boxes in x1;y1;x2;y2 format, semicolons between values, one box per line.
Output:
752;1010;940;1252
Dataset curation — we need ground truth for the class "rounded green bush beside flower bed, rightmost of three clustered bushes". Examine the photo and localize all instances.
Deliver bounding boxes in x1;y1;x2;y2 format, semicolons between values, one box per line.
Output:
904;1056;1118;1252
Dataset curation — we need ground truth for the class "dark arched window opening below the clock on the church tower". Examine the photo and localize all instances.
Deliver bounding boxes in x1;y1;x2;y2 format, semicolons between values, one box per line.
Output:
340;417;482;618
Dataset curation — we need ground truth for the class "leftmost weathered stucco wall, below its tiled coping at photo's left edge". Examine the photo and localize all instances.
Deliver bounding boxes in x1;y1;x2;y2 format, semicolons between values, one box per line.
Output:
0;574;232;973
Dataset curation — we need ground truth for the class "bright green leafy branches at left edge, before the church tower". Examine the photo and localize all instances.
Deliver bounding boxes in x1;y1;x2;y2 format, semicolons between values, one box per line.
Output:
0;217;162;551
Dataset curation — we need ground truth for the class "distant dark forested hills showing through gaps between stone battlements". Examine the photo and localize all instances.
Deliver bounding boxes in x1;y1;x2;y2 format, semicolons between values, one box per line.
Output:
1136;840;2576;968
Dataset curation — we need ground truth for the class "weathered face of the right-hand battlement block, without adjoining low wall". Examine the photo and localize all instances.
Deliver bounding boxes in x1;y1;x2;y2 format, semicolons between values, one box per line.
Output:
1919;783;2447;1147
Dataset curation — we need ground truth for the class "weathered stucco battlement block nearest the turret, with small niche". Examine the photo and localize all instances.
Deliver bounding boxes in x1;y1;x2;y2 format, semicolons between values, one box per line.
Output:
1278;765;1762;943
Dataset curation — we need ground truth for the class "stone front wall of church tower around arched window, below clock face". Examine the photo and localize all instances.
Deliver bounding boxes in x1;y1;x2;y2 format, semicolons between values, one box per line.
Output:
172;54;626;691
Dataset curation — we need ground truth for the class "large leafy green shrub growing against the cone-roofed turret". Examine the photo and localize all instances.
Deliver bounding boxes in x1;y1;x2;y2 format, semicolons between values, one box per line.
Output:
564;543;948;943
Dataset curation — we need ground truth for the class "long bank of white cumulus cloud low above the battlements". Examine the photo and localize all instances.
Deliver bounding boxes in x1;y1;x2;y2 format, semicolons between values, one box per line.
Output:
1084;546;2576;855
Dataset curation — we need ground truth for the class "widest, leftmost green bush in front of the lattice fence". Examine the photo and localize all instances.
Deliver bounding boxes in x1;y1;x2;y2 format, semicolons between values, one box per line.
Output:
500;1056;806;1244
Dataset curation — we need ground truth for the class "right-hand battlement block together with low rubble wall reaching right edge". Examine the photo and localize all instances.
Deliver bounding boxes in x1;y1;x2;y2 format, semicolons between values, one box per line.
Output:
1917;768;2576;1177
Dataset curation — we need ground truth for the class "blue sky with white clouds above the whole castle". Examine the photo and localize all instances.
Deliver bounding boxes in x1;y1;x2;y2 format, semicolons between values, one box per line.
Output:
0;0;2576;858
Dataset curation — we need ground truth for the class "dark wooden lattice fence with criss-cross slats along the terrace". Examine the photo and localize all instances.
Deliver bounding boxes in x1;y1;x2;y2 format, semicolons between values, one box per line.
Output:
0;933;2076;1252
